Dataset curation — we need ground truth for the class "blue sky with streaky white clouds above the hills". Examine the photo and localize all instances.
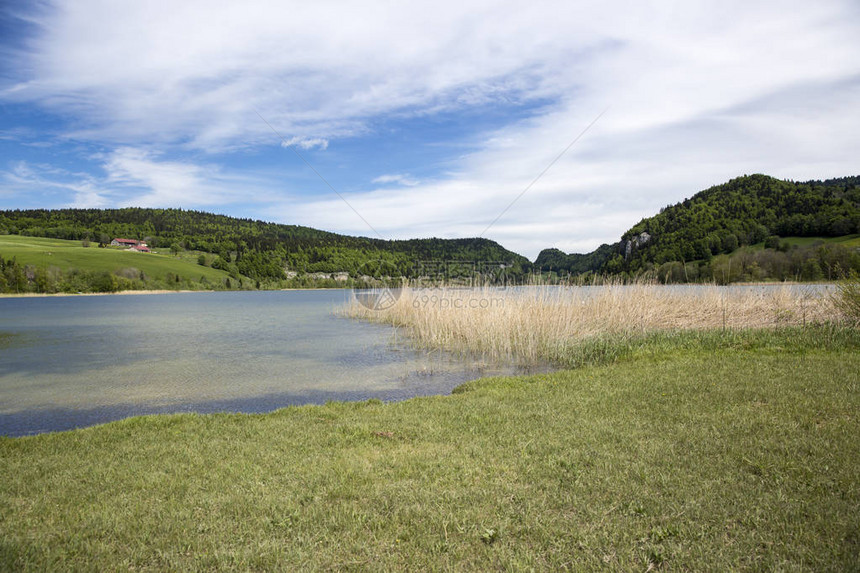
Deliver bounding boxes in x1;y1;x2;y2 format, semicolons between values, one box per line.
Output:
0;0;860;259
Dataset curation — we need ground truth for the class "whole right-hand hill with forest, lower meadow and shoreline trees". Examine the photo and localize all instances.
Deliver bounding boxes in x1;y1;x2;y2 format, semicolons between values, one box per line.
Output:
535;175;860;280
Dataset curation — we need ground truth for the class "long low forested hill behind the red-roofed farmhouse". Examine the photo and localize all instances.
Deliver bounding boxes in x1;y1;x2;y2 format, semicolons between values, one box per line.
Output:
0;208;531;279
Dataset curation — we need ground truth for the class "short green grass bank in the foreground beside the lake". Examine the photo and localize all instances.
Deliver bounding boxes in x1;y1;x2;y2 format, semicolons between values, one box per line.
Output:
0;327;860;571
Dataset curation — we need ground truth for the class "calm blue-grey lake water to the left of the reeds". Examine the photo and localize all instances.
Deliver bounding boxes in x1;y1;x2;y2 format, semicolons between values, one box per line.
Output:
0;291;532;436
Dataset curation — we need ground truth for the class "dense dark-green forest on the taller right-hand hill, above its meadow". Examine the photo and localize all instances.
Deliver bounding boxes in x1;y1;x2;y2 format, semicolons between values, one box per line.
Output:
535;175;860;274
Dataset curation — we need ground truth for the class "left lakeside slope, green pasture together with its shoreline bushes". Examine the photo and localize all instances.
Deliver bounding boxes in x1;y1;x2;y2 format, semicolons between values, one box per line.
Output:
0;235;237;292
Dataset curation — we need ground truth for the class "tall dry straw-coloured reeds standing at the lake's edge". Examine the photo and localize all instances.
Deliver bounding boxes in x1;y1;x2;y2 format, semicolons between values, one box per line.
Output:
343;283;838;364
